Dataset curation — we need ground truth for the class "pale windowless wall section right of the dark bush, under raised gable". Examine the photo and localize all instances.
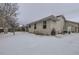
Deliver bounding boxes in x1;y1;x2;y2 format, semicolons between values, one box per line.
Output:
50;16;65;34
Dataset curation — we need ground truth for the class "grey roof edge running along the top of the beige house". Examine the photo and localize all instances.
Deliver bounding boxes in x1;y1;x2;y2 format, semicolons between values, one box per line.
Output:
27;15;79;25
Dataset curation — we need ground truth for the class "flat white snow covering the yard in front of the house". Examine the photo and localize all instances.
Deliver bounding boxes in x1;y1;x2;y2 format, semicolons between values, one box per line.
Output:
0;32;79;55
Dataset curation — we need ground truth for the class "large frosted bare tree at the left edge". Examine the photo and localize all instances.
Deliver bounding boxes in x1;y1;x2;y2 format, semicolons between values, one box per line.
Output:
0;3;18;33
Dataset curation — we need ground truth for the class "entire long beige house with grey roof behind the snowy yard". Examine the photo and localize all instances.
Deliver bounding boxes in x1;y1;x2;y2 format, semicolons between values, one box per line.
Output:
27;15;79;35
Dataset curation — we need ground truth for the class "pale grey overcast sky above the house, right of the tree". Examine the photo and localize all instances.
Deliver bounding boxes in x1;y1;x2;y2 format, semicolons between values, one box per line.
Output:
18;3;79;24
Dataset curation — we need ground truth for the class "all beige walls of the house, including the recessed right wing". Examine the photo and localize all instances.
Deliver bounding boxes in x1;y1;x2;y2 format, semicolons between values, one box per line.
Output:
28;19;79;35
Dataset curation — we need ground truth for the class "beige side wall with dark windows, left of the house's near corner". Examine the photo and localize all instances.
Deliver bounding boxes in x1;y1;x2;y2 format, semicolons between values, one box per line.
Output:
29;20;51;34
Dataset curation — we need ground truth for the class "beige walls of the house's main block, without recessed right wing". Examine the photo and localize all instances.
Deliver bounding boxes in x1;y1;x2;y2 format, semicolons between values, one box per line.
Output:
29;20;64;35
